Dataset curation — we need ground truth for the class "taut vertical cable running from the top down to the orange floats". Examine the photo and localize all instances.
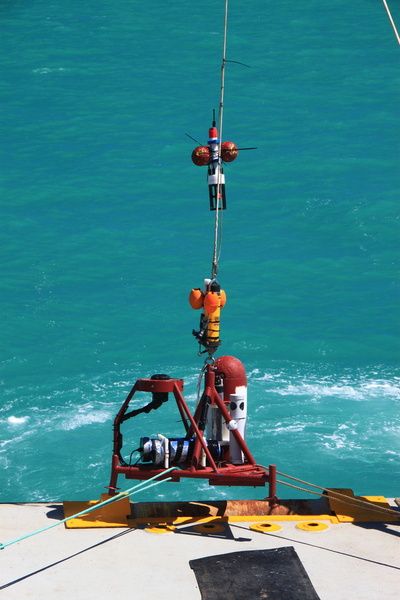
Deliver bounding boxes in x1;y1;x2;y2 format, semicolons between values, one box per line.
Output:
211;0;229;279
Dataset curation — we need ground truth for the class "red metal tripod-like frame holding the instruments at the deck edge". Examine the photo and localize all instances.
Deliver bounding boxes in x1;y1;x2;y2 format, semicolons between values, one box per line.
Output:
109;365;276;501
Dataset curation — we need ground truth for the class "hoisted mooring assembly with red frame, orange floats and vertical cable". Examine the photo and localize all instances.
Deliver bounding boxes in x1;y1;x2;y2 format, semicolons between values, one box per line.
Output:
109;0;276;496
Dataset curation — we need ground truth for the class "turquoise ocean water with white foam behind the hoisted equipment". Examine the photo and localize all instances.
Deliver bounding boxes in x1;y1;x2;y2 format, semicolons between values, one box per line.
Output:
0;0;400;501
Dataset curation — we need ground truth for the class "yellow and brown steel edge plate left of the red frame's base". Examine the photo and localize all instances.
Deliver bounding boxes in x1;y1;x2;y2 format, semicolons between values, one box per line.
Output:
64;494;131;529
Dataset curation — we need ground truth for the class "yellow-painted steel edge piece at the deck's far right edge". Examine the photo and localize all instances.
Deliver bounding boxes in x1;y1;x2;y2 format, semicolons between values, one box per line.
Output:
328;488;400;523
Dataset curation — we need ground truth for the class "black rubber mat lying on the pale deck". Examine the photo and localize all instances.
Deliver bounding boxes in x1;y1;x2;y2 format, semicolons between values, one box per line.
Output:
189;546;320;600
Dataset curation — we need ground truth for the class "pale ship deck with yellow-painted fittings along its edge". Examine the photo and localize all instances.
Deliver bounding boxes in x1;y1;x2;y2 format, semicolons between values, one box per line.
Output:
0;500;400;600
